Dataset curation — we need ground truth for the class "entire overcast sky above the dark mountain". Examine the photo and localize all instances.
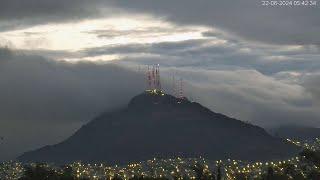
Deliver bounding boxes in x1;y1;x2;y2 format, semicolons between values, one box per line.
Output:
0;0;320;161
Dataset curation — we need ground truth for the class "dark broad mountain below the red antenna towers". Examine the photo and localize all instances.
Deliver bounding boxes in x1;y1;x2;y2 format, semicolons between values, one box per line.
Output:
18;91;298;164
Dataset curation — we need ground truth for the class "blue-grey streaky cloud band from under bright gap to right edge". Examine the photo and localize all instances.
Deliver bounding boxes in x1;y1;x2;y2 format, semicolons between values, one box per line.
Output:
80;37;320;75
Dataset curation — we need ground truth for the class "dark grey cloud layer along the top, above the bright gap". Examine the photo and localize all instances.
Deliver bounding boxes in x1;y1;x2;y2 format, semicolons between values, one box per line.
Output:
0;0;320;45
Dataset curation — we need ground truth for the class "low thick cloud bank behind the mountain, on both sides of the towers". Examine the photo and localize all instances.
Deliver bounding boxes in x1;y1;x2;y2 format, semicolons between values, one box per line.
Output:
0;49;320;159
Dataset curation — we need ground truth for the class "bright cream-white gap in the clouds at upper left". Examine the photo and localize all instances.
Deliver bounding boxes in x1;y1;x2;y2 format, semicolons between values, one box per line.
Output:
0;15;209;61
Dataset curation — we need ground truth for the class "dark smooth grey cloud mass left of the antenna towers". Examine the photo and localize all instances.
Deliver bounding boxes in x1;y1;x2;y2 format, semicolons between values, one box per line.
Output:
0;49;145;159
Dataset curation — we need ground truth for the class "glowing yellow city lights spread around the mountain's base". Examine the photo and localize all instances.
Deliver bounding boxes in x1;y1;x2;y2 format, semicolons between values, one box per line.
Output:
0;139;320;180
